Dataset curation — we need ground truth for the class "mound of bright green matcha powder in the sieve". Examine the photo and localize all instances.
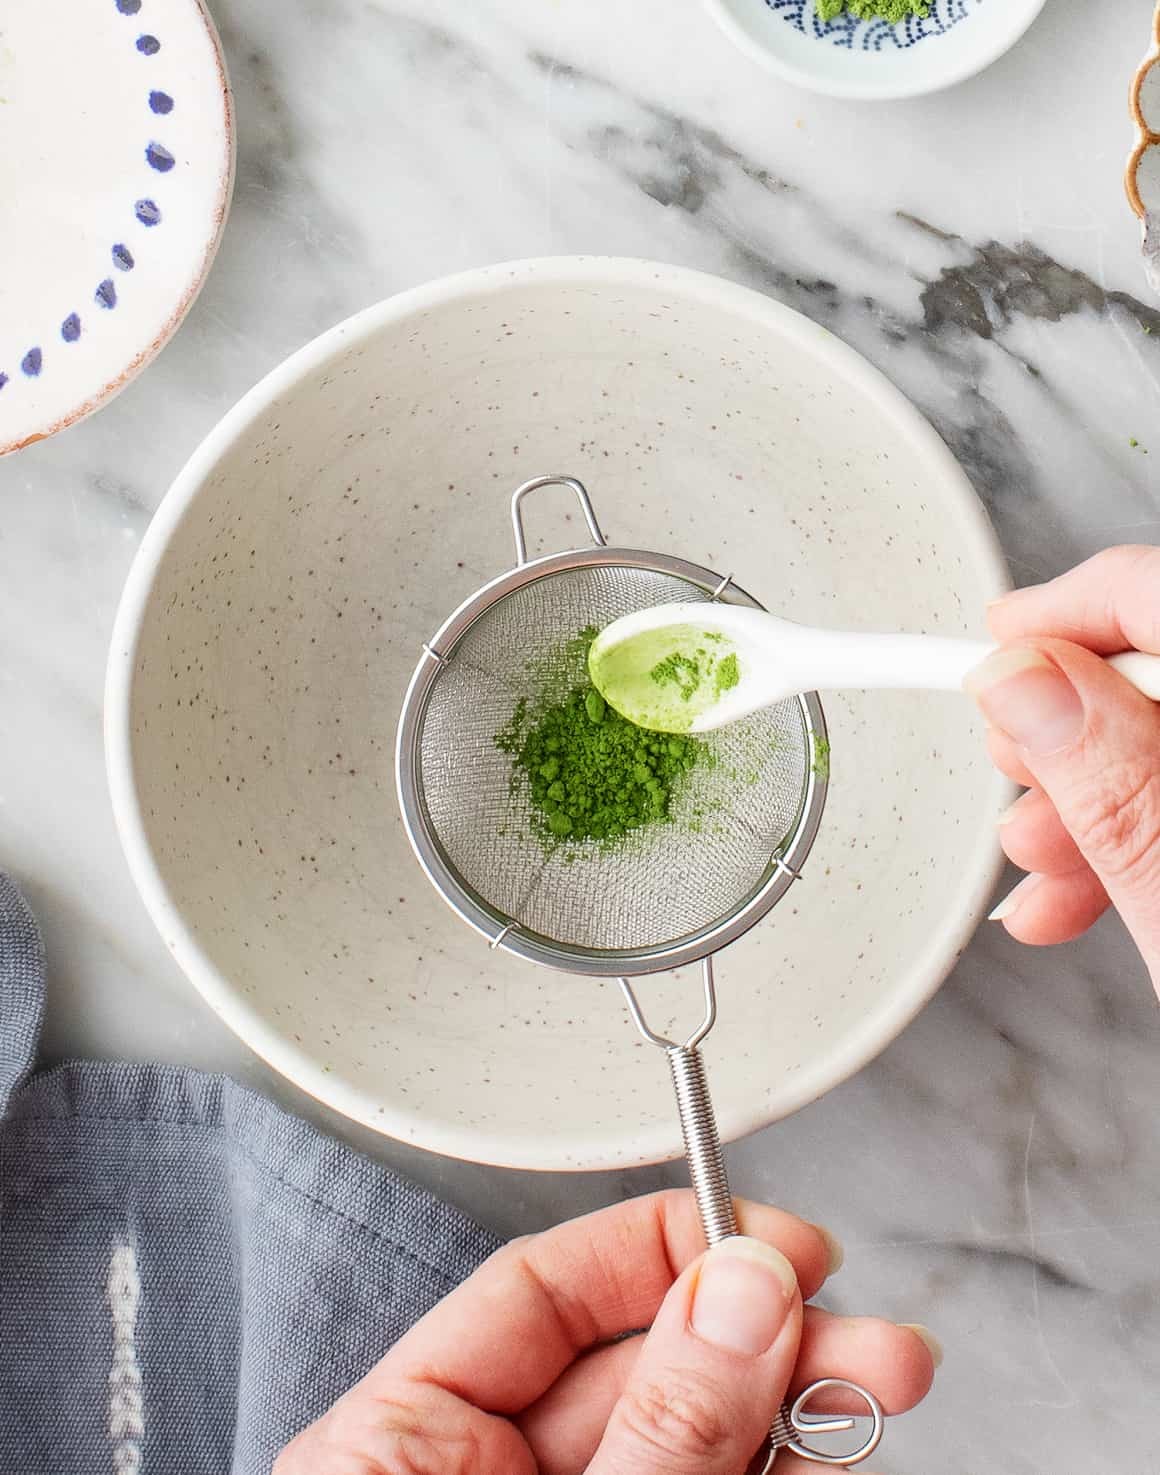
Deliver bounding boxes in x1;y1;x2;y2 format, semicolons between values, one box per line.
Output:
496;631;711;842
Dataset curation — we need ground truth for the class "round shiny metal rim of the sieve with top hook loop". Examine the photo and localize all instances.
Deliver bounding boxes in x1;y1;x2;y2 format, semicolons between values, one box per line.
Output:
396;476;828;978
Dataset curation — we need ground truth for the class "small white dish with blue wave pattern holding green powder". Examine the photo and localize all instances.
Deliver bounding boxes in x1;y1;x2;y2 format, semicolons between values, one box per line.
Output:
705;0;1043;99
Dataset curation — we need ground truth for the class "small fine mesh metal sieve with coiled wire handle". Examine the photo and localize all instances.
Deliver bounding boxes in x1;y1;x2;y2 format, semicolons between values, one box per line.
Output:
396;476;883;1475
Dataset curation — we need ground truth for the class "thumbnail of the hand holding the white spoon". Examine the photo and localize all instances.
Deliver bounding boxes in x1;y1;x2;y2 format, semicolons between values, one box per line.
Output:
964;648;1083;758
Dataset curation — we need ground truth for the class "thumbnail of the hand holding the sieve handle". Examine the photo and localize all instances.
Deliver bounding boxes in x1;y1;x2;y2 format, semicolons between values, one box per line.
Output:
692;1235;797;1357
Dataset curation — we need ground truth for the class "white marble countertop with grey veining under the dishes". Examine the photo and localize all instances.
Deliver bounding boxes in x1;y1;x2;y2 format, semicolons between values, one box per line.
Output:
0;0;1160;1475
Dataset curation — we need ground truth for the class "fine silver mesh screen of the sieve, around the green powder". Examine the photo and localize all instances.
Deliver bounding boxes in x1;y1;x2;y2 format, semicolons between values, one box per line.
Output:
416;565;813;951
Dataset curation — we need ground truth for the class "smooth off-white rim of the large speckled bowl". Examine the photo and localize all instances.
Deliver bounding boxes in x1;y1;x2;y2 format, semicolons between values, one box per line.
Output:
103;257;1011;1171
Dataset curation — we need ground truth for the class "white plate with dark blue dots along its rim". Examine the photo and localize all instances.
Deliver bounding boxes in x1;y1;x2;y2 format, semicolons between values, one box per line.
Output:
0;0;233;454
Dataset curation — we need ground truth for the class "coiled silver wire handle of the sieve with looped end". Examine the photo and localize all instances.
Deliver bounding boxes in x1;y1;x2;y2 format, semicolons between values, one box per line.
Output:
618;957;885;1475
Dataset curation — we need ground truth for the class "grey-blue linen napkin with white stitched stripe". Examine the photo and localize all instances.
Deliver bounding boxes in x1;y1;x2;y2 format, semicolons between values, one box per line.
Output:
0;875;496;1475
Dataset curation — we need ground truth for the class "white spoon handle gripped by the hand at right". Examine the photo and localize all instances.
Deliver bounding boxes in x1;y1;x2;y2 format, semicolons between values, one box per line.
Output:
810;634;1160;702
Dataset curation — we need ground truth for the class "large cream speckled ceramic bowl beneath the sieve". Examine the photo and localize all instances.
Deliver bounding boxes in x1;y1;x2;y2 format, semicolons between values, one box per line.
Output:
106;258;1004;1168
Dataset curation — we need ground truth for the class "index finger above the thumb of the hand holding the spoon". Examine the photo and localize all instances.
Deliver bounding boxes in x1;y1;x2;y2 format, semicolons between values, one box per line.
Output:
989;547;1160;655
